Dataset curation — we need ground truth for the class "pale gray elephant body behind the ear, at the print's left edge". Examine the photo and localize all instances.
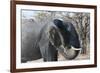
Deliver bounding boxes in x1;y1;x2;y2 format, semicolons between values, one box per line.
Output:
21;19;43;63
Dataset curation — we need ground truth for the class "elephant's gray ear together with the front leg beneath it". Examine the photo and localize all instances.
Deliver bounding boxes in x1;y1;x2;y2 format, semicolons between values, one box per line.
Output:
38;22;61;61
